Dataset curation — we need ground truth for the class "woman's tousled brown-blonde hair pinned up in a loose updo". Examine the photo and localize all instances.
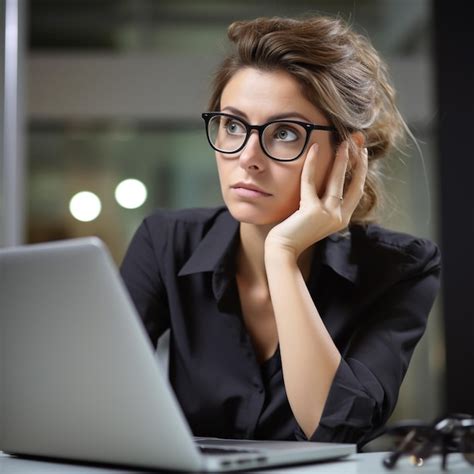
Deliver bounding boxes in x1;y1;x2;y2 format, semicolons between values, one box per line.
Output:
209;16;408;223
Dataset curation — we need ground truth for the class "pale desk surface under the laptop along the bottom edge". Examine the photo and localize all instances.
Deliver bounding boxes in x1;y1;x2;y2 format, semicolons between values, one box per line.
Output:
0;453;474;474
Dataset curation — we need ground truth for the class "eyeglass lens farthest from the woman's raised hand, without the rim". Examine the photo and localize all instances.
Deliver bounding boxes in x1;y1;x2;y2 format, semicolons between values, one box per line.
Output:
207;115;247;153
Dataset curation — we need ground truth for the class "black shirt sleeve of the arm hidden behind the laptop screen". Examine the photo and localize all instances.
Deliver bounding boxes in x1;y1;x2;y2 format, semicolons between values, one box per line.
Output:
120;220;169;347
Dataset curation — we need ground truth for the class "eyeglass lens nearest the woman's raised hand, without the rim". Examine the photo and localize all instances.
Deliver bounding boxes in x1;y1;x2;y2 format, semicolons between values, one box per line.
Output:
262;122;307;160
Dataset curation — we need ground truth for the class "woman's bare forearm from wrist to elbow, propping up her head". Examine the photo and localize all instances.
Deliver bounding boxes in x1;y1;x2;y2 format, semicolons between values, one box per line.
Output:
265;248;341;437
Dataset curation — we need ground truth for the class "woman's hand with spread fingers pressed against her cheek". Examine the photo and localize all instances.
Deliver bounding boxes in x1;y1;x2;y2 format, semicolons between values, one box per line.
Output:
265;141;367;258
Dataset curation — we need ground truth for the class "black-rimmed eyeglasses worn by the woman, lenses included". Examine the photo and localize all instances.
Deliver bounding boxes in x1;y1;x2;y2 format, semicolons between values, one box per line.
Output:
202;112;337;161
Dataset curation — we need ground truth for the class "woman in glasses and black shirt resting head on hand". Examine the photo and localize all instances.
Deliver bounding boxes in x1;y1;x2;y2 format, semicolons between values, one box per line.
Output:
122;13;440;444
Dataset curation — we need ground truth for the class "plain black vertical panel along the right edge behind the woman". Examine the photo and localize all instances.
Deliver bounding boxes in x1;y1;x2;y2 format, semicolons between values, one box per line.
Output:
434;0;474;414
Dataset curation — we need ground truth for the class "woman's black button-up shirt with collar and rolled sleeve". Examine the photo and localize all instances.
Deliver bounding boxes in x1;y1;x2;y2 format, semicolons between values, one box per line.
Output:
121;207;440;444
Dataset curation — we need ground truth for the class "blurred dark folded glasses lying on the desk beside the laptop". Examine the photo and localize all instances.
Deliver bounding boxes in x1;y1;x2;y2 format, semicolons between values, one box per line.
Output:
383;414;474;469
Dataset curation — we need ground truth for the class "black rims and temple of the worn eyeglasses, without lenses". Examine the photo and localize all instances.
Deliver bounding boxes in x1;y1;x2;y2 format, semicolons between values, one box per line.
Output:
201;112;337;162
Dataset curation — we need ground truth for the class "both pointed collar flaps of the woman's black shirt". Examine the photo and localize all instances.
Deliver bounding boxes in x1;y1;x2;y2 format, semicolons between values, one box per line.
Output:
178;211;358;286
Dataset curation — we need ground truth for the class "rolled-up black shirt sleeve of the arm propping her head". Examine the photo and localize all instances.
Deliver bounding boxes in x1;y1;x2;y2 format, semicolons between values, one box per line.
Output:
296;239;440;445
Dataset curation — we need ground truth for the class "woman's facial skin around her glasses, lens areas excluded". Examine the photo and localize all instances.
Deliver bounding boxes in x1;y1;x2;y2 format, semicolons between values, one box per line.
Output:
216;68;335;225
